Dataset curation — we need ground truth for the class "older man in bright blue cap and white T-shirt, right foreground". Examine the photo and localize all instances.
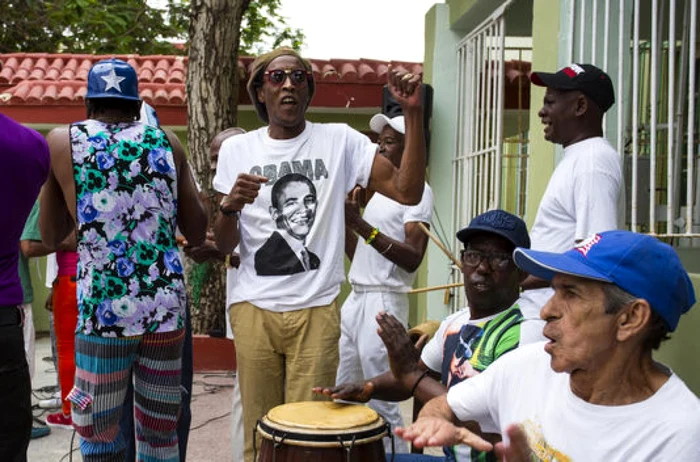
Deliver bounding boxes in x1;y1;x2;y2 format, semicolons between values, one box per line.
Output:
397;231;700;462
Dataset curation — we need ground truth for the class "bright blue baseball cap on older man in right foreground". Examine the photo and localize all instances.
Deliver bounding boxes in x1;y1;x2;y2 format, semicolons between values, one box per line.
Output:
513;231;695;332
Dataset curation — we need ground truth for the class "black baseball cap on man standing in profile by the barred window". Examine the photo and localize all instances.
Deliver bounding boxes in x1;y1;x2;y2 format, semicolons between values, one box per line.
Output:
530;64;615;112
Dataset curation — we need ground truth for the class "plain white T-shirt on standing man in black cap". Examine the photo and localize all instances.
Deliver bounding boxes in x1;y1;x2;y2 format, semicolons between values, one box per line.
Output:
520;137;622;318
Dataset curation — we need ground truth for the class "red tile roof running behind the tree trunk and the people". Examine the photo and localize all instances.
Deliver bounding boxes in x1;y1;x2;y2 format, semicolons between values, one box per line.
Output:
0;53;530;125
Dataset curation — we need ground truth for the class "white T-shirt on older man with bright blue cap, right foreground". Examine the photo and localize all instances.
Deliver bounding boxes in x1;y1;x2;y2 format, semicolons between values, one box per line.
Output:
447;343;700;462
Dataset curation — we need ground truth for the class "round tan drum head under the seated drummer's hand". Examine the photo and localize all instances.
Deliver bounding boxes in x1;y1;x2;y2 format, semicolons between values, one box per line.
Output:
267;401;379;430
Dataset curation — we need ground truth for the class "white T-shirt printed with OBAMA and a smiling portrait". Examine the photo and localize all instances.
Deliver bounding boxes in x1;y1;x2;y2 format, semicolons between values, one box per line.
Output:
214;121;376;312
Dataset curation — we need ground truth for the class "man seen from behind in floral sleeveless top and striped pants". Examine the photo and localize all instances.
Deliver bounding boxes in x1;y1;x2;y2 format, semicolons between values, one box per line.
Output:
40;59;207;462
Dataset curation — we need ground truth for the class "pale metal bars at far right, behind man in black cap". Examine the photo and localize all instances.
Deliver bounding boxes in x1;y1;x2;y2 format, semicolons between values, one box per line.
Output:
567;0;700;238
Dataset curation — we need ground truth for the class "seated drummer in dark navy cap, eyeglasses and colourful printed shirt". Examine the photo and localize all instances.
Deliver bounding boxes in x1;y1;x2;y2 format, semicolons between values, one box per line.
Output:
314;210;530;461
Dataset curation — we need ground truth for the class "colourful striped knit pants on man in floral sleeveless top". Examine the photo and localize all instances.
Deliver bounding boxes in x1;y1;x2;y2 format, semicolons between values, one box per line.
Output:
68;329;185;462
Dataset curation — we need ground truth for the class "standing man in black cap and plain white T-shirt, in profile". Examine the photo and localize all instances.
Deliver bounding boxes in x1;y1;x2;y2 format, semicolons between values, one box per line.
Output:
521;64;622;336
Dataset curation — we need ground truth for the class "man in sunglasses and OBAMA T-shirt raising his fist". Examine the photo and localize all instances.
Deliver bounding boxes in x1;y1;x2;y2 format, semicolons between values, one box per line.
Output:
213;48;426;462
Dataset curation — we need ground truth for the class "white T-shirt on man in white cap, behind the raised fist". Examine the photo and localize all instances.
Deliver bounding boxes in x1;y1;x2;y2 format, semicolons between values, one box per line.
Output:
348;184;433;292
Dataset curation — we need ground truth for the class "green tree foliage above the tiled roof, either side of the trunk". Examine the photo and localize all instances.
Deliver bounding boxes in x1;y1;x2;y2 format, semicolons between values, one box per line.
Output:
0;0;304;55
